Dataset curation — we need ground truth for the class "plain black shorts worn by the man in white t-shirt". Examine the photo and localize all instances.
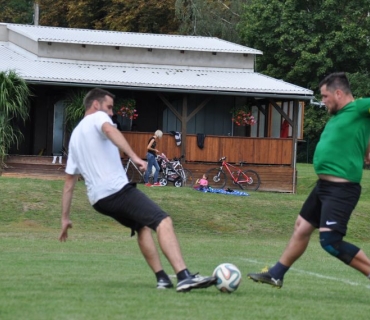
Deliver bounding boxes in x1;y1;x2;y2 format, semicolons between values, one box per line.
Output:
93;183;168;236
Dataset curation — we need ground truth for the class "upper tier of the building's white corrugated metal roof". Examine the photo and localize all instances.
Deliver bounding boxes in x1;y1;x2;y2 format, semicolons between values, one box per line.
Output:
7;24;262;54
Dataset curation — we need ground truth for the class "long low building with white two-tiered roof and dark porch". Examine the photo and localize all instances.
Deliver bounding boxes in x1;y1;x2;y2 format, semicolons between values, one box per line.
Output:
0;23;313;192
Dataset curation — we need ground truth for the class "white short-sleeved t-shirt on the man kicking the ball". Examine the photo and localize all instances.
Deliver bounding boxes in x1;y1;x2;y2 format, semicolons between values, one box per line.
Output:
65;111;128;205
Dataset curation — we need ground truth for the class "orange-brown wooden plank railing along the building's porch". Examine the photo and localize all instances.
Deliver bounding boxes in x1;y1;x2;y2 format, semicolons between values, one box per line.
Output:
123;131;292;165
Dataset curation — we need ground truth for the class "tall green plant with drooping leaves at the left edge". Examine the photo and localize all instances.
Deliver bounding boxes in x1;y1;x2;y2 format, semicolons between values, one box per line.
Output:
0;70;31;173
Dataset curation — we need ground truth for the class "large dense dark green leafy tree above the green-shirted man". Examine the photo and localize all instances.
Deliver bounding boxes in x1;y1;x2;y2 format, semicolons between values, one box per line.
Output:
238;0;370;90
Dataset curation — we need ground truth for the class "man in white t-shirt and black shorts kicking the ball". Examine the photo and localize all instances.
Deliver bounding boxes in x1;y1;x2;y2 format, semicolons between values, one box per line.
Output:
59;88;216;292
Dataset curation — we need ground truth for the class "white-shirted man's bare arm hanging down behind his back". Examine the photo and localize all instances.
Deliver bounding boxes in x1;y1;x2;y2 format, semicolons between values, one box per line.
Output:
59;174;78;241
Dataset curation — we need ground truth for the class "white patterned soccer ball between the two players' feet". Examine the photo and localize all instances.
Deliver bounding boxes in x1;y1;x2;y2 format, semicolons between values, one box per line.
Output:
213;263;242;293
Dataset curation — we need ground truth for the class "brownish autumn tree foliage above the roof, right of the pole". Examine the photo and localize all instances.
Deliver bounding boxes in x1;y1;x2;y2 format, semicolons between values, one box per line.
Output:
40;0;178;34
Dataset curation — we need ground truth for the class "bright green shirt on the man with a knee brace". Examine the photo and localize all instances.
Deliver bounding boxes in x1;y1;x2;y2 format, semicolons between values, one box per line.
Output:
313;99;370;183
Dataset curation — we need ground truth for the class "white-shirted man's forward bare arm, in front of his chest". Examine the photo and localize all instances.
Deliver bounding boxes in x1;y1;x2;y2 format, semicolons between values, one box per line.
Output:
102;122;147;171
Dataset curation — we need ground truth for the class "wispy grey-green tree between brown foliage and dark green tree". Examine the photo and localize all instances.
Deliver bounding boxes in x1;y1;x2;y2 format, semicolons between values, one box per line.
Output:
176;0;244;43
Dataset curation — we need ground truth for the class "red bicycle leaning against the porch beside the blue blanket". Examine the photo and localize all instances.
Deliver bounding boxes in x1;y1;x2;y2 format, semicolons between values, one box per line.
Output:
206;157;261;191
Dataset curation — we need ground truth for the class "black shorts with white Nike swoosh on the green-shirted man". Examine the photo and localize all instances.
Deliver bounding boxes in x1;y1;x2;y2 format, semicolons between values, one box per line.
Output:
300;180;361;235
